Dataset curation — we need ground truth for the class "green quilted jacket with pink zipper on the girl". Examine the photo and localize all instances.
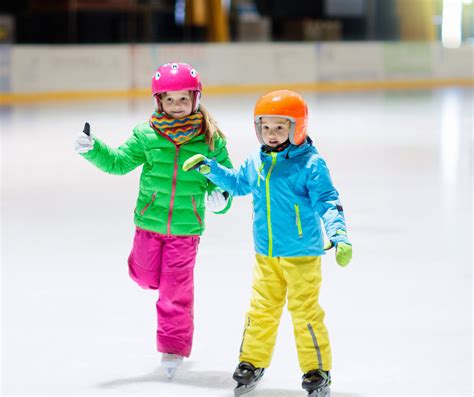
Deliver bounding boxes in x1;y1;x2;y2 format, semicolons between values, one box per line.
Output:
83;122;232;235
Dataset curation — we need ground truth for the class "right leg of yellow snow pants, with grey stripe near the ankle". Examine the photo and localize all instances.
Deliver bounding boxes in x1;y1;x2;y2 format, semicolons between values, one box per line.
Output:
280;257;332;373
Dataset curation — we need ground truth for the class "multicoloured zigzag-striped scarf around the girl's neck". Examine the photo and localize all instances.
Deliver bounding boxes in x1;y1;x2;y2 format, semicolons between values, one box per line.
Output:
150;112;203;145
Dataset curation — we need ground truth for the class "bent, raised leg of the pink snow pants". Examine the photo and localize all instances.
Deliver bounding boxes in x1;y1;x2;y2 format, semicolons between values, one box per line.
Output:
128;228;163;289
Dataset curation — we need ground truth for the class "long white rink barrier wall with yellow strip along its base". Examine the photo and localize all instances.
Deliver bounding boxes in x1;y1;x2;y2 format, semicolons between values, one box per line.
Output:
0;42;474;104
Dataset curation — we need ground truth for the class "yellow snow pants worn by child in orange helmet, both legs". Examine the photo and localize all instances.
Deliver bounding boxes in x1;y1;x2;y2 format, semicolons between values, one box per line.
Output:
239;254;332;373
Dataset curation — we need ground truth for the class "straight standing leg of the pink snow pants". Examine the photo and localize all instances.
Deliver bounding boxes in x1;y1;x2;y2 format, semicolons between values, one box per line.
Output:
156;236;199;357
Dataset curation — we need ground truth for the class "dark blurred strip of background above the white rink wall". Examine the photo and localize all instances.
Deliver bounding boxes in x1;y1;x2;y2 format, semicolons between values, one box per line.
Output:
0;0;474;44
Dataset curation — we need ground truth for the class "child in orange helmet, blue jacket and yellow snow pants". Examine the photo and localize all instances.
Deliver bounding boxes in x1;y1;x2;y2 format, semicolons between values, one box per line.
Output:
184;90;352;397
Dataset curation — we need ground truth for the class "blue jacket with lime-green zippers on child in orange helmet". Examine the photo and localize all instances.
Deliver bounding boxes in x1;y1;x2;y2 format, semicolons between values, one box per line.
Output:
206;138;347;257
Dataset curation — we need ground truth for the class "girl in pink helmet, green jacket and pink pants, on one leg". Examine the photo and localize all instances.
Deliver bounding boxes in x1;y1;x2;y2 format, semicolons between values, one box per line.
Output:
76;63;232;378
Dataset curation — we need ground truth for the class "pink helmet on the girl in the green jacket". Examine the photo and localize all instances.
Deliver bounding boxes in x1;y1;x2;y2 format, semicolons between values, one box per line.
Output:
151;62;202;112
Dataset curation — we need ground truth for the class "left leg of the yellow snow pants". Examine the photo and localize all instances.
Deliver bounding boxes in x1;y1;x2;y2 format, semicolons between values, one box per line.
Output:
239;254;286;368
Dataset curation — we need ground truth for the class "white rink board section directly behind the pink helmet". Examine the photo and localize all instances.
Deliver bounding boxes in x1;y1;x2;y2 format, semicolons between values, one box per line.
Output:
132;43;317;88
